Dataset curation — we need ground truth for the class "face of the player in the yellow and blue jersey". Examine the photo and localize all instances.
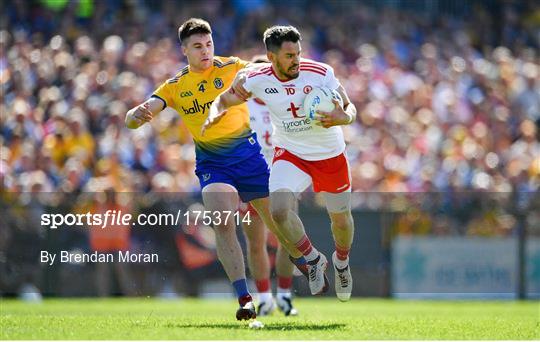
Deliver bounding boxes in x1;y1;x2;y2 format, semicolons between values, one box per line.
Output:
182;34;214;72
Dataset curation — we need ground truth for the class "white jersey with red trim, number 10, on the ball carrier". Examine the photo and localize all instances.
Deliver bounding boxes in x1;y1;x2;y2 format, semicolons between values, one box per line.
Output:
244;59;345;160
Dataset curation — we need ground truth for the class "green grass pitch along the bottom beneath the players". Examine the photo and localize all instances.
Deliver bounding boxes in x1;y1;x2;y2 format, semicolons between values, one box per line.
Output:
0;298;540;340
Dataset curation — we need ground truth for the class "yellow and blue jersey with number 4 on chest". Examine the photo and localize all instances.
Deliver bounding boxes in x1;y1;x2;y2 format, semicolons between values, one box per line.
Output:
152;56;260;165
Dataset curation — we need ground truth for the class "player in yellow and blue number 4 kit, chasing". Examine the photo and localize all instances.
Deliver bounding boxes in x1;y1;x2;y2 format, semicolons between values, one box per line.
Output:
126;18;305;320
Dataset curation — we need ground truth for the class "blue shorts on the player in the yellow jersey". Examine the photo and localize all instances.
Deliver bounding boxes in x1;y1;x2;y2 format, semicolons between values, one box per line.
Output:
195;153;270;203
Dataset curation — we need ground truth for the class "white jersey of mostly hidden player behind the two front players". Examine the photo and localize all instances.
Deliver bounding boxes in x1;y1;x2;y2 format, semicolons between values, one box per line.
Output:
247;97;274;165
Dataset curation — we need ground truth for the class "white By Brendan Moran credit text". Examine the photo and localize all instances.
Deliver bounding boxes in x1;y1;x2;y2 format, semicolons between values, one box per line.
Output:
40;251;159;266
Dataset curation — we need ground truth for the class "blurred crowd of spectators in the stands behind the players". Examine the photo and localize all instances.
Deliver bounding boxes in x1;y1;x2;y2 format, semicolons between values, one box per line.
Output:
0;0;540;298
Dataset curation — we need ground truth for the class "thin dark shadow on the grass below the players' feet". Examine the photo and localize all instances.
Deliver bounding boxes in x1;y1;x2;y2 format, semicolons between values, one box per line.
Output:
165;322;346;331
